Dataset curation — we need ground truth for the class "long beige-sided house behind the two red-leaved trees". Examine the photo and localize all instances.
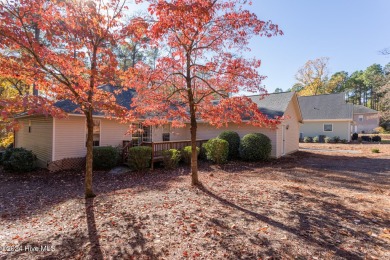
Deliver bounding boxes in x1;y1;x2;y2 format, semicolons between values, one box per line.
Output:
15;85;302;170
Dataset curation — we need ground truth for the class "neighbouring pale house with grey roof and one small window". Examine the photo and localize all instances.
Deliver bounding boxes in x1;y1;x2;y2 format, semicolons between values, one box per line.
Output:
298;93;353;141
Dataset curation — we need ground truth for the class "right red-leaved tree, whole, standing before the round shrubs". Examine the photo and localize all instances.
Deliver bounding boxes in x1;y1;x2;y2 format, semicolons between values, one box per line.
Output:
134;0;282;185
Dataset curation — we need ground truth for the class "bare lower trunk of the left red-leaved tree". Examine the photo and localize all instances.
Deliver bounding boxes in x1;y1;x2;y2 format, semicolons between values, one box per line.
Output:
85;109;95;198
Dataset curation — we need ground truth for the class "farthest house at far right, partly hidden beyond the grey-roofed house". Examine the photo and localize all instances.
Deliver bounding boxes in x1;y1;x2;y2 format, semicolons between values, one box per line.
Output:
352;105;379;133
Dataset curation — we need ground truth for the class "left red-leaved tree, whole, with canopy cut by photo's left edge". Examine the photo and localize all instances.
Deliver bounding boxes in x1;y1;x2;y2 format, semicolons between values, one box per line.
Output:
0;0;145;197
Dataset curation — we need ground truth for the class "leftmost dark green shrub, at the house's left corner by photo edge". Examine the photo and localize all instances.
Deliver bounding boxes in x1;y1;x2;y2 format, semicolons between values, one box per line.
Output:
2;148;37;172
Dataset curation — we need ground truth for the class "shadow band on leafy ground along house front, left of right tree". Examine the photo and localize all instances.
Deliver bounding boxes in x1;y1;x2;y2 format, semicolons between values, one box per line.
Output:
0;167;189;220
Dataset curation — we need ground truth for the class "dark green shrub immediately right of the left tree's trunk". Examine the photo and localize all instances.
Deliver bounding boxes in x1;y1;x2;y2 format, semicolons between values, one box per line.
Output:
93;146;119;170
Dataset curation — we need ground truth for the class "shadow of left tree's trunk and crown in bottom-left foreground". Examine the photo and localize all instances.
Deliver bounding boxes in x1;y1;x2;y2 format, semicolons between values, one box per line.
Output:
3;198;162;260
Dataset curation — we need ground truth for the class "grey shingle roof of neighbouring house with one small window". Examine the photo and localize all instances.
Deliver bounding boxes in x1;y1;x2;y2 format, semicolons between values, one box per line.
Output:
298;93;353;120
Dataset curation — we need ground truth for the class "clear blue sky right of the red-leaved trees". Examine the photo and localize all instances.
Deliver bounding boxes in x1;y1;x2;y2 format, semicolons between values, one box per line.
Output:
249;0;390;92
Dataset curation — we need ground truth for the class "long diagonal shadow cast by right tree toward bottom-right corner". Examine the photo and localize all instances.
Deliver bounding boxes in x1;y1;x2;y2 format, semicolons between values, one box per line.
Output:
200;186;390;259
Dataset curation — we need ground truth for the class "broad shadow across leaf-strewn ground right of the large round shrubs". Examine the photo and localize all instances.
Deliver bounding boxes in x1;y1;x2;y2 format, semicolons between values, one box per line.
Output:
210;152;390;191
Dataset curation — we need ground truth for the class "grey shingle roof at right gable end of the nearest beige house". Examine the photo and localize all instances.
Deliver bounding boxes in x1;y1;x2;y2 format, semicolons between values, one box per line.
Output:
248;92;295;118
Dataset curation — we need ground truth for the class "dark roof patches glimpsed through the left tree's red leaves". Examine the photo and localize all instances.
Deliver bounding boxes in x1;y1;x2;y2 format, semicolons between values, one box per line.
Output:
54;84;135;115
